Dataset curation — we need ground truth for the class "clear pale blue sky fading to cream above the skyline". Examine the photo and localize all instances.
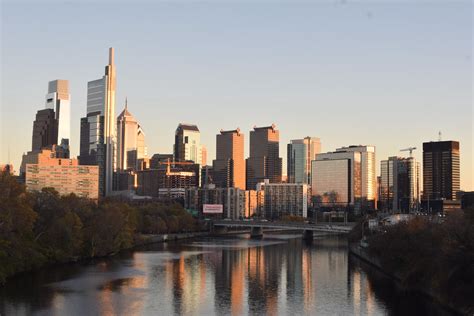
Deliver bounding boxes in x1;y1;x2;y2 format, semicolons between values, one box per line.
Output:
0;0;474;190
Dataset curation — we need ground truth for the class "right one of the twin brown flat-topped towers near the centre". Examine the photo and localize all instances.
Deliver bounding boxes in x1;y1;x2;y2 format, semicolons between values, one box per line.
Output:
246;124;282;190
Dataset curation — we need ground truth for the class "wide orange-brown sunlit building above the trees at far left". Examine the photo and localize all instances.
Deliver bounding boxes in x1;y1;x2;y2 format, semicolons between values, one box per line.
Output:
25;147;99;200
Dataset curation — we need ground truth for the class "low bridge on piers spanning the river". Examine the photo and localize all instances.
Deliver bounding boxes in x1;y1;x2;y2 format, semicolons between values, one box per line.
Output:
212;220;356;239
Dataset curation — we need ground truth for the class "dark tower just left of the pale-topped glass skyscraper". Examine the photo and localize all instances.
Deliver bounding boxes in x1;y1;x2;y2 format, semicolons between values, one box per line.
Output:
31;109;58;151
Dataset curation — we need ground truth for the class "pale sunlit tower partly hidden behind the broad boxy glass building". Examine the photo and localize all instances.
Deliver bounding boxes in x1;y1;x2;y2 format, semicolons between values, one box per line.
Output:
336;145;378;209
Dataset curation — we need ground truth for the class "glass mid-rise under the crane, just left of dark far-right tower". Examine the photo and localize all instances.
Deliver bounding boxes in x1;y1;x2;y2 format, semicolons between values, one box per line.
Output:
379;157;420;212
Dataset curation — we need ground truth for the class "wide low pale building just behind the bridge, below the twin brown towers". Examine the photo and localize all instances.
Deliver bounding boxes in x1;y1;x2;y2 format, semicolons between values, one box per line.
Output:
256;180;311;220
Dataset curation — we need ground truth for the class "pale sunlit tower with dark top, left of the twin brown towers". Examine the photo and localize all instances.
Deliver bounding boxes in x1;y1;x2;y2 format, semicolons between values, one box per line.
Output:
173;124;202;165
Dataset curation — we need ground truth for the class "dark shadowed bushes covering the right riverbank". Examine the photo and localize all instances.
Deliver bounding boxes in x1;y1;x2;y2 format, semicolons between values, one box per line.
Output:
349;209;474;315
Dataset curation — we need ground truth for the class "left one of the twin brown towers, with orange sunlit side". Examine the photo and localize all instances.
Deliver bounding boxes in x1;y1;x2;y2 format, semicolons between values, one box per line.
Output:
213;128;245;190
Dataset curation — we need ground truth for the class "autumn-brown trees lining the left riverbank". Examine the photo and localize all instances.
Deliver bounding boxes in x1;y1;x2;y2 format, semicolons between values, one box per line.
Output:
0;172;201;285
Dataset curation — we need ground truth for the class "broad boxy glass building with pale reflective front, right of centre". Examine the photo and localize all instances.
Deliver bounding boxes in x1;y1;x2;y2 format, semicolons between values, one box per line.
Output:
311;151;362;210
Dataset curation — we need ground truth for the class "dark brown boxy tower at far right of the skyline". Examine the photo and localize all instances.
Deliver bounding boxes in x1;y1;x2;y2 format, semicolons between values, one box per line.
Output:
423;141;460;200
